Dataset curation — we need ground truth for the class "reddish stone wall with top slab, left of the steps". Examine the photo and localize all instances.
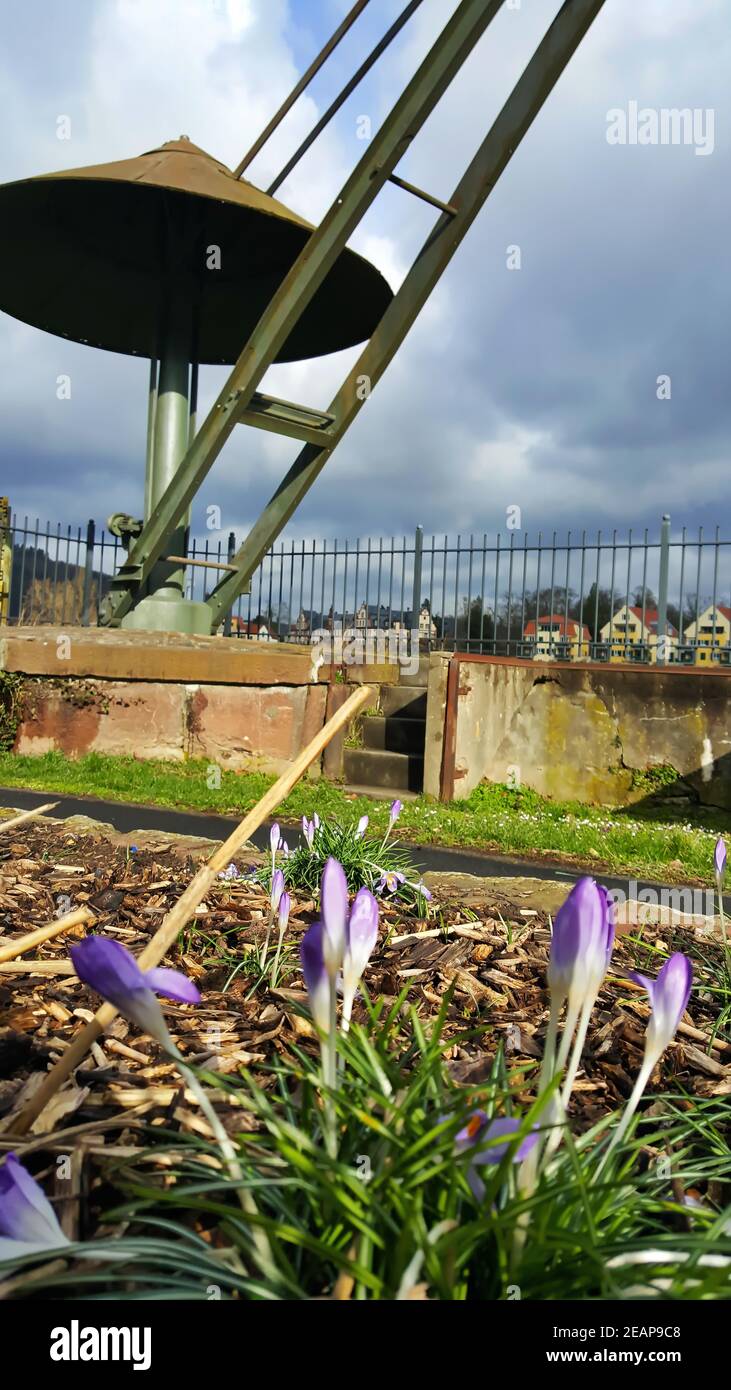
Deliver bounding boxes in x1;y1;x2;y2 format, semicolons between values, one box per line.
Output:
0;626;399;776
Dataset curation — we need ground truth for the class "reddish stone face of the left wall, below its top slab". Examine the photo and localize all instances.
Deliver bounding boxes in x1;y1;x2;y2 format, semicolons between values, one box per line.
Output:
14;677;329;776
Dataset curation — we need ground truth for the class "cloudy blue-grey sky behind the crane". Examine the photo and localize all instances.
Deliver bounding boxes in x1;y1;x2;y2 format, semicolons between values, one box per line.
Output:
0;0;731;567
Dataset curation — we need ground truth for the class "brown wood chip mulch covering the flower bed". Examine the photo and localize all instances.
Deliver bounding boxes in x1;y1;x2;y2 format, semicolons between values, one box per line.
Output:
0;821;731;1151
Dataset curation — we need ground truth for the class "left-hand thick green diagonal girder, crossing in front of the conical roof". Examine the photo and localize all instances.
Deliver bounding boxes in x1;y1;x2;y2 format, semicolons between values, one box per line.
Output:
103;0;503;624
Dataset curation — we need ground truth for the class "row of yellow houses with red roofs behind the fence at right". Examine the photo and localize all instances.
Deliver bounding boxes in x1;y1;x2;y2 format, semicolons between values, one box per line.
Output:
523;603;731;666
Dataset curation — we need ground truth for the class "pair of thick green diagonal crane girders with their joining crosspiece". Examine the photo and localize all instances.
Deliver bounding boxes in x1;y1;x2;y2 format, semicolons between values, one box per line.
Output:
106;0;603;631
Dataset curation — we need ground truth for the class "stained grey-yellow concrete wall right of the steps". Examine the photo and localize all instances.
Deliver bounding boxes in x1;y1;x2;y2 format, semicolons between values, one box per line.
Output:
425;655;731;808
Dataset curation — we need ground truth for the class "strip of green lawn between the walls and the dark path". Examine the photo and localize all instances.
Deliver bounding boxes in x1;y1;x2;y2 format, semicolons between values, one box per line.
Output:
0;752;731;885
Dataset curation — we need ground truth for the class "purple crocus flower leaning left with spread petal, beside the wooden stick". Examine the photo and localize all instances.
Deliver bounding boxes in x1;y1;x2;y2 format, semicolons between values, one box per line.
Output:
71;937;200;1048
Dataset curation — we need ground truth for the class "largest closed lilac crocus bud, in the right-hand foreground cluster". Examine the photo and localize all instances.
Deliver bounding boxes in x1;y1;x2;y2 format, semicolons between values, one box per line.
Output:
548;878;614;1008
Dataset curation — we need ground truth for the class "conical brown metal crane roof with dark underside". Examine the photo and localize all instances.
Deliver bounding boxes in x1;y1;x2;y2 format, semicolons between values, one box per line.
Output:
0;136;392;363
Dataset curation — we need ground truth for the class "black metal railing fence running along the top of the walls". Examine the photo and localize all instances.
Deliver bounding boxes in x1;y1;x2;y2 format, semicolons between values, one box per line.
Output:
1;517;731;664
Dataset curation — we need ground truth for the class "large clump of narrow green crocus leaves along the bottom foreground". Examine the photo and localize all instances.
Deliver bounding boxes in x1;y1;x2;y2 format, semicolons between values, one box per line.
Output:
4;995;731;1301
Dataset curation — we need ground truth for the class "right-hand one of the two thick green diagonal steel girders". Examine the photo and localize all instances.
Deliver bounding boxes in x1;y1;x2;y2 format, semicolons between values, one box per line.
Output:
206;0;605;632
